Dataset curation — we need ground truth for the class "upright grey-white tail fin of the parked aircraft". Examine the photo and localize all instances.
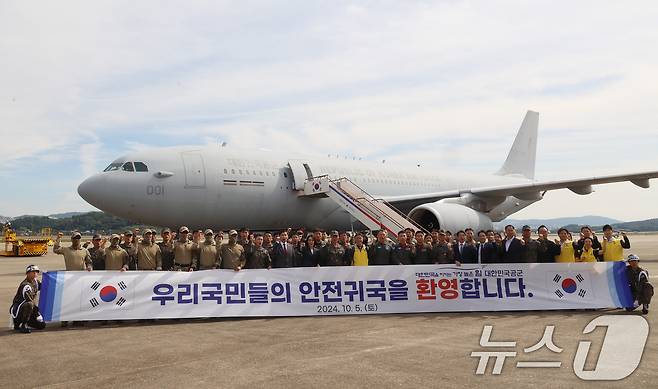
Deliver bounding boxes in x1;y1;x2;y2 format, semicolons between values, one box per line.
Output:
496;111;539;180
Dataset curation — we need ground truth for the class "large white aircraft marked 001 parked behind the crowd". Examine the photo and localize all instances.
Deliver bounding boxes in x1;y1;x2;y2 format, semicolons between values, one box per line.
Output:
78;111;658;234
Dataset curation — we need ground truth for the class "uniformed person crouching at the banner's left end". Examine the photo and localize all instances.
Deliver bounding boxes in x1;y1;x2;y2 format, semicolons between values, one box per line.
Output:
9;265;46;334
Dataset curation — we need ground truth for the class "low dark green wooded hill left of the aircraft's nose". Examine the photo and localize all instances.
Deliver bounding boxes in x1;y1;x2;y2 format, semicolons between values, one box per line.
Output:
11;212;160;233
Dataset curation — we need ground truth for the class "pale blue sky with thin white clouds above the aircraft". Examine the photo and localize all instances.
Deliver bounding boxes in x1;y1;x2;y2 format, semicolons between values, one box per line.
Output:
0;1;658;220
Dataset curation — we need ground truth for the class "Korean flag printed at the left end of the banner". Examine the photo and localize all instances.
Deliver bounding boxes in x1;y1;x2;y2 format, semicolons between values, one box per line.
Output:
80;277;134;311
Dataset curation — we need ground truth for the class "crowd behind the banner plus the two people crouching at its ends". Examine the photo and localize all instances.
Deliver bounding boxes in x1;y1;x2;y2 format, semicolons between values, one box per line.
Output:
10;225;653;332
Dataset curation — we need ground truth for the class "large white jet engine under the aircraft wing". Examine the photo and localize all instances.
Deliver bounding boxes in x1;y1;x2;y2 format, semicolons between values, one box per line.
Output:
409;201;493;233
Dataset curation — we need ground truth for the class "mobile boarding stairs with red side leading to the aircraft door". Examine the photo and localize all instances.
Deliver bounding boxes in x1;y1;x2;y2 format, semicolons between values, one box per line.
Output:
299;175;423;238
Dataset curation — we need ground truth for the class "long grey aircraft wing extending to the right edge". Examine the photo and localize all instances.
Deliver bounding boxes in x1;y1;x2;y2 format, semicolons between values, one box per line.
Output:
382;171;658;208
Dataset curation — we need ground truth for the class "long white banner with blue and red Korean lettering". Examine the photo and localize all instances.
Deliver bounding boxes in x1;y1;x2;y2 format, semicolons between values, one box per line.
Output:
39;262;632;321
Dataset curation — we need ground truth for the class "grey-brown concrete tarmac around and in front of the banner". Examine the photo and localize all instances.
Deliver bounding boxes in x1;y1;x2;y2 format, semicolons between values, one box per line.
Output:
0;235;658;388
